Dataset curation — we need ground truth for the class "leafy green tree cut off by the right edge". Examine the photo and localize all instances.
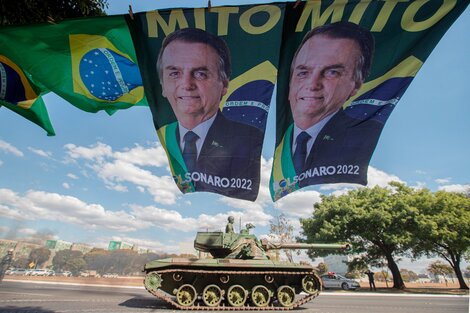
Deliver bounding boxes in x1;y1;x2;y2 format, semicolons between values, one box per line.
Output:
413;191;470;289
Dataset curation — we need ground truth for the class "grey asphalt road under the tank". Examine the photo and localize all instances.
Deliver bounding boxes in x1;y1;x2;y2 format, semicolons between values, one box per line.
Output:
0;281;469;313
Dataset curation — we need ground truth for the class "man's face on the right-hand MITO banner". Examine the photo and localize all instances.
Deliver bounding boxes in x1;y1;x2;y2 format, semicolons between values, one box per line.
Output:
289;35;361;129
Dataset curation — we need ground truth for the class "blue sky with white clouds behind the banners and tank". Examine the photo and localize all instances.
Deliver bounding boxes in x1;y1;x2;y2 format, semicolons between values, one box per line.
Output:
0;0;470;268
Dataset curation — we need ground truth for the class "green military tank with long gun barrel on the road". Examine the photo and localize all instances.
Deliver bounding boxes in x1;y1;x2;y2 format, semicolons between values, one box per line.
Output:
144;220;349;311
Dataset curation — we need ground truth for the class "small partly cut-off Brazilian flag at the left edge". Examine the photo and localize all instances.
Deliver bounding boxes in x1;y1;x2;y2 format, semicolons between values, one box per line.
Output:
0;54;55;136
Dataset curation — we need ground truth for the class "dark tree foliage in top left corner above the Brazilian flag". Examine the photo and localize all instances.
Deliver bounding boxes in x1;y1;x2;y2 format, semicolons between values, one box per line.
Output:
0;0;108;25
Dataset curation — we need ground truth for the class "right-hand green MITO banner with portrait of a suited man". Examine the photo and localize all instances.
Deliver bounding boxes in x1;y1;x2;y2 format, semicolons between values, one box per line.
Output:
270;0;468;201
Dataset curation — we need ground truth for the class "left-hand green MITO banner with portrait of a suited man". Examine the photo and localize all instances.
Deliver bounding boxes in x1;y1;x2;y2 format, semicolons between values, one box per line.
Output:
129;4;284;201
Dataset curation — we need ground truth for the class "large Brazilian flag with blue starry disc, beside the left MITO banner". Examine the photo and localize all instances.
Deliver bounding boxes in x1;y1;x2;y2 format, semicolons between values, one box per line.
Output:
0;16;146;114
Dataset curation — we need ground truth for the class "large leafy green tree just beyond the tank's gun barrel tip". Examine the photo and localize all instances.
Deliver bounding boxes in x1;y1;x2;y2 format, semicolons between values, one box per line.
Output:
301;182;418;289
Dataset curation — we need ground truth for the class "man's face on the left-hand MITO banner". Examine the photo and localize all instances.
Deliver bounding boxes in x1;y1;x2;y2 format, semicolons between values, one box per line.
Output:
162;40;227;129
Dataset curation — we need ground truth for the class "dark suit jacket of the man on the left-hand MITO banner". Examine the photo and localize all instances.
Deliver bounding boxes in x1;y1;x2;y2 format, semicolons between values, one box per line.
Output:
176;112;263;200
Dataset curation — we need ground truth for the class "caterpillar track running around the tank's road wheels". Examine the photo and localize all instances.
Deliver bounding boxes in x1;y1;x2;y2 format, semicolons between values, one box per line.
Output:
144;269;321;311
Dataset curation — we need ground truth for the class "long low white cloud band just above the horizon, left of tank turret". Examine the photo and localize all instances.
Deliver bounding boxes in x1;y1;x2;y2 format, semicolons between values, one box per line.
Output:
0;189;266;233
